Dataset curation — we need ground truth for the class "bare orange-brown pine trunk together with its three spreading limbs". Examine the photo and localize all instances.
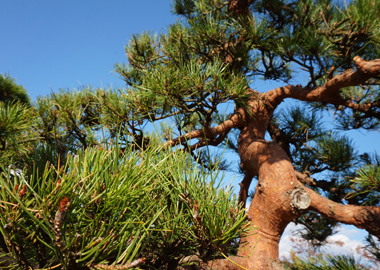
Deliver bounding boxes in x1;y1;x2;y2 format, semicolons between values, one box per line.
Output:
180;57;380;269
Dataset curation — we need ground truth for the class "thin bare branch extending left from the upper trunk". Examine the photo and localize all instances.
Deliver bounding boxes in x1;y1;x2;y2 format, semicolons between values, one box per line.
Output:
164;109;245;148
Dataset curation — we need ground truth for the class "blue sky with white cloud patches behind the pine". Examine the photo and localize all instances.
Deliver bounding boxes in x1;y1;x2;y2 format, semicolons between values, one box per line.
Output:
0;0;380;266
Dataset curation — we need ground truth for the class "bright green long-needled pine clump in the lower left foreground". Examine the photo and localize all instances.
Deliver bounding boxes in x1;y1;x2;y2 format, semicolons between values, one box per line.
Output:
0;142;250;269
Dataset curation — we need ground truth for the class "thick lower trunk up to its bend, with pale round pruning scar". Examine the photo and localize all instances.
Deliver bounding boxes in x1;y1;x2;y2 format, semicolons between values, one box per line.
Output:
238;139;310;269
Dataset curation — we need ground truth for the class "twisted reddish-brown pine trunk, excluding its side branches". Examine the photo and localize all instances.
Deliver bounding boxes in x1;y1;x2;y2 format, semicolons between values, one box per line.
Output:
203;100;310;269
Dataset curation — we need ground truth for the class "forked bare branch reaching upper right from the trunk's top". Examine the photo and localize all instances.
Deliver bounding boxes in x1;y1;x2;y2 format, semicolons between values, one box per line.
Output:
266;56;380;108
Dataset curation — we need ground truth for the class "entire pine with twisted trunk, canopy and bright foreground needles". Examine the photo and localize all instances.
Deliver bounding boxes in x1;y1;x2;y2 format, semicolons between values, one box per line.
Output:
0;0;380;269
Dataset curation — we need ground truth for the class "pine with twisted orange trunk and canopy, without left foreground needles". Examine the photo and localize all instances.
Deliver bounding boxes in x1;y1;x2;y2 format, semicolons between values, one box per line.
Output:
112;0;380;269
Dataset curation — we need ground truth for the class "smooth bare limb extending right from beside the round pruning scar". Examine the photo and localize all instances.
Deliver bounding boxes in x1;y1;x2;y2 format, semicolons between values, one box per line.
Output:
304;187;380;237
